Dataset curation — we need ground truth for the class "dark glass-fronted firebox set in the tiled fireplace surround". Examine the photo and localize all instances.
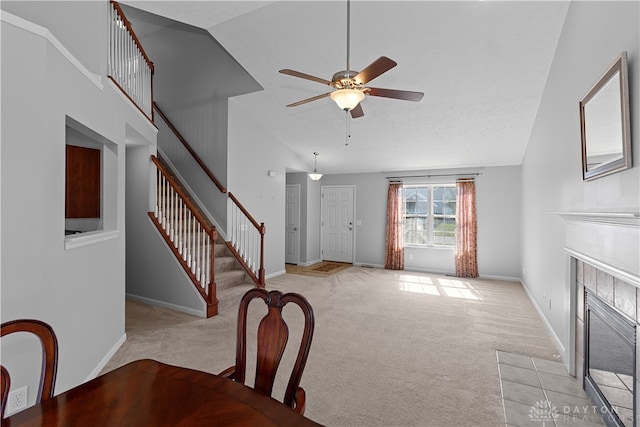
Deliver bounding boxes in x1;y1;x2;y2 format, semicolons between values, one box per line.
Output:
584;289;636;427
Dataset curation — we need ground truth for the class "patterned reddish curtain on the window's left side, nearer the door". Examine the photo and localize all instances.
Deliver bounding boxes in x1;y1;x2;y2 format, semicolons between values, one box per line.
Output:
384;183;404;270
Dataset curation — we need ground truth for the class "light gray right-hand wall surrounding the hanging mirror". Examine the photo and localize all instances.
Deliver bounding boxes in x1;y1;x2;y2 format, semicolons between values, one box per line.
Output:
522;2;640;358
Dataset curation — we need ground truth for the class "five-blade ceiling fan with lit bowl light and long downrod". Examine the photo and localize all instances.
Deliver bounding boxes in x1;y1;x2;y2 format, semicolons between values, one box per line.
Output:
280;0;424;119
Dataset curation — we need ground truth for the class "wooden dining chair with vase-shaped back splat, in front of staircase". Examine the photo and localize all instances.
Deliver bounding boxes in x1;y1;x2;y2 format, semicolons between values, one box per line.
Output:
220;288;315;414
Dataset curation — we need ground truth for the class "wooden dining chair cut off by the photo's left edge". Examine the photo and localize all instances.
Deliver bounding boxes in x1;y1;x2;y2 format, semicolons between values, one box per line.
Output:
0;319;58;419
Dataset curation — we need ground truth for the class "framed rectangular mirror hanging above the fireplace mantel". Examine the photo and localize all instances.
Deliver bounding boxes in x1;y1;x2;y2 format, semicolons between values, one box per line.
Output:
580;52;631;181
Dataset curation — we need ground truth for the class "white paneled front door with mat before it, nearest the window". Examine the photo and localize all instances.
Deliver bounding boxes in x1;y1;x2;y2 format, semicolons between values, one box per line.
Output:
322;185;355;262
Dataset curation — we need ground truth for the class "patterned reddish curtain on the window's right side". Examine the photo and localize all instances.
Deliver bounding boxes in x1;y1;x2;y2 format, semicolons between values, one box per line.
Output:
456;180;478;277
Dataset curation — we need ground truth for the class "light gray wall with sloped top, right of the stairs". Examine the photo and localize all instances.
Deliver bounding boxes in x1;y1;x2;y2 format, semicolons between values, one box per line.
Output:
227;99;307;276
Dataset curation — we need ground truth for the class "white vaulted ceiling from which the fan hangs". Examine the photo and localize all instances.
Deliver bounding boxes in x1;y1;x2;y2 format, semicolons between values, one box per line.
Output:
123;0;577;173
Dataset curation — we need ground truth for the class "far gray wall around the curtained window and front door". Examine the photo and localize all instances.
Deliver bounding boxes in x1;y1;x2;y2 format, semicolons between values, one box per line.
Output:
317;166;521;280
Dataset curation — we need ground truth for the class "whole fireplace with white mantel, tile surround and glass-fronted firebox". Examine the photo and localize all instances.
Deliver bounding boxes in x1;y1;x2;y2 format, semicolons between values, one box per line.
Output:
561;213;640;427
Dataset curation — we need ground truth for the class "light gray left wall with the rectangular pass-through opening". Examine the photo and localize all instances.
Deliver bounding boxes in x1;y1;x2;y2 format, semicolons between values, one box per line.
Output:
0;8;155;402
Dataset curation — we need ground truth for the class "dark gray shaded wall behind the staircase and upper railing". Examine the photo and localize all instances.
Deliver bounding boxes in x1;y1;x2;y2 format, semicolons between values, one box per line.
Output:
122;5;262;236
